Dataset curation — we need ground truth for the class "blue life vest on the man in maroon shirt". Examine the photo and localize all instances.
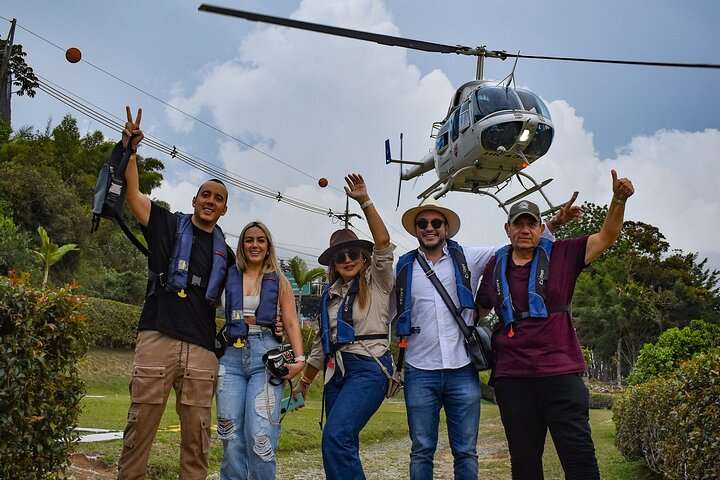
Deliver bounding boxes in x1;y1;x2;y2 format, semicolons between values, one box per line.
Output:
493;238;569;326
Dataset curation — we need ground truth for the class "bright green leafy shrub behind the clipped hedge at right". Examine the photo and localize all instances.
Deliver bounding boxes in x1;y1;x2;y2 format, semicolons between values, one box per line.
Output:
628;320;720;385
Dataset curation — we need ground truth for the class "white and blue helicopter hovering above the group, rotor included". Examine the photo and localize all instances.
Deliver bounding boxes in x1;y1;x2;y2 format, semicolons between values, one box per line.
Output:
198;4;720;215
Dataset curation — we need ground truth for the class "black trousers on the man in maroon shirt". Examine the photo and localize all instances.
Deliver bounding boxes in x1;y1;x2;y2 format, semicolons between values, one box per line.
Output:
495;373;600;480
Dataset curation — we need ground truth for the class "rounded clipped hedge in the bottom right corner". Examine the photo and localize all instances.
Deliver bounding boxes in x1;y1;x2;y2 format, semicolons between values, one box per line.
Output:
613;348;720;480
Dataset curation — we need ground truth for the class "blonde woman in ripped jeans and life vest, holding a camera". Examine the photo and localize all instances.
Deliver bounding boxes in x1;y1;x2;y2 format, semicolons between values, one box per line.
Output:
216;222;305;479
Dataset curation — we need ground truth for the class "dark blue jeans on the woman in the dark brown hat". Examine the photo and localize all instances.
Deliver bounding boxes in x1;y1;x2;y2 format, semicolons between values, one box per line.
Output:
322;353;392;480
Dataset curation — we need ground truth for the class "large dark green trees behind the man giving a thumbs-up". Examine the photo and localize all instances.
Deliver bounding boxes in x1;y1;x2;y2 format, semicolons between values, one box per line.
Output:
556;203;720;382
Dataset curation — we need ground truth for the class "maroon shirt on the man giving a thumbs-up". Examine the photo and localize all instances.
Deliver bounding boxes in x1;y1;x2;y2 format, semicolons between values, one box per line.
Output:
475;237;588;378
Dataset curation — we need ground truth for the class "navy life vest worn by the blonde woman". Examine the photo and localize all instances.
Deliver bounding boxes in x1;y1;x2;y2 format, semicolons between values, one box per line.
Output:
225;267;280;340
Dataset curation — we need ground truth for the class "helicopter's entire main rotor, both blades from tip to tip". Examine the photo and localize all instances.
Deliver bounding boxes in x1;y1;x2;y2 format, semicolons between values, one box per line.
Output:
198;3;720;68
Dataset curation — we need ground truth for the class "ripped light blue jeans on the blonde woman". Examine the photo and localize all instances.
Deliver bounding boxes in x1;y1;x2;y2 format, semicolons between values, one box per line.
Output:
217;330;285;480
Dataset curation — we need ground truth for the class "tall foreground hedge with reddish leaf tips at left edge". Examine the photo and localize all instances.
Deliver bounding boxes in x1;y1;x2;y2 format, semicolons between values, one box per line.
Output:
0;275;88;479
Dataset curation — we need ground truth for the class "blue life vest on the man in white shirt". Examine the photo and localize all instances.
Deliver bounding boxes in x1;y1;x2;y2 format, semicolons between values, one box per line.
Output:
395;240;475;336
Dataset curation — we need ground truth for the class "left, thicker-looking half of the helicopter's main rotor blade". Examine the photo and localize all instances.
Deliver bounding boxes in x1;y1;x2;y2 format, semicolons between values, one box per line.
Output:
198;3;479;55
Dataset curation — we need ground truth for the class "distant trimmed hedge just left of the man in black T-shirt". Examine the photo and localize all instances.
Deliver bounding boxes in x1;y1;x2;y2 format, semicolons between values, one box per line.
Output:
87;298;141;348
